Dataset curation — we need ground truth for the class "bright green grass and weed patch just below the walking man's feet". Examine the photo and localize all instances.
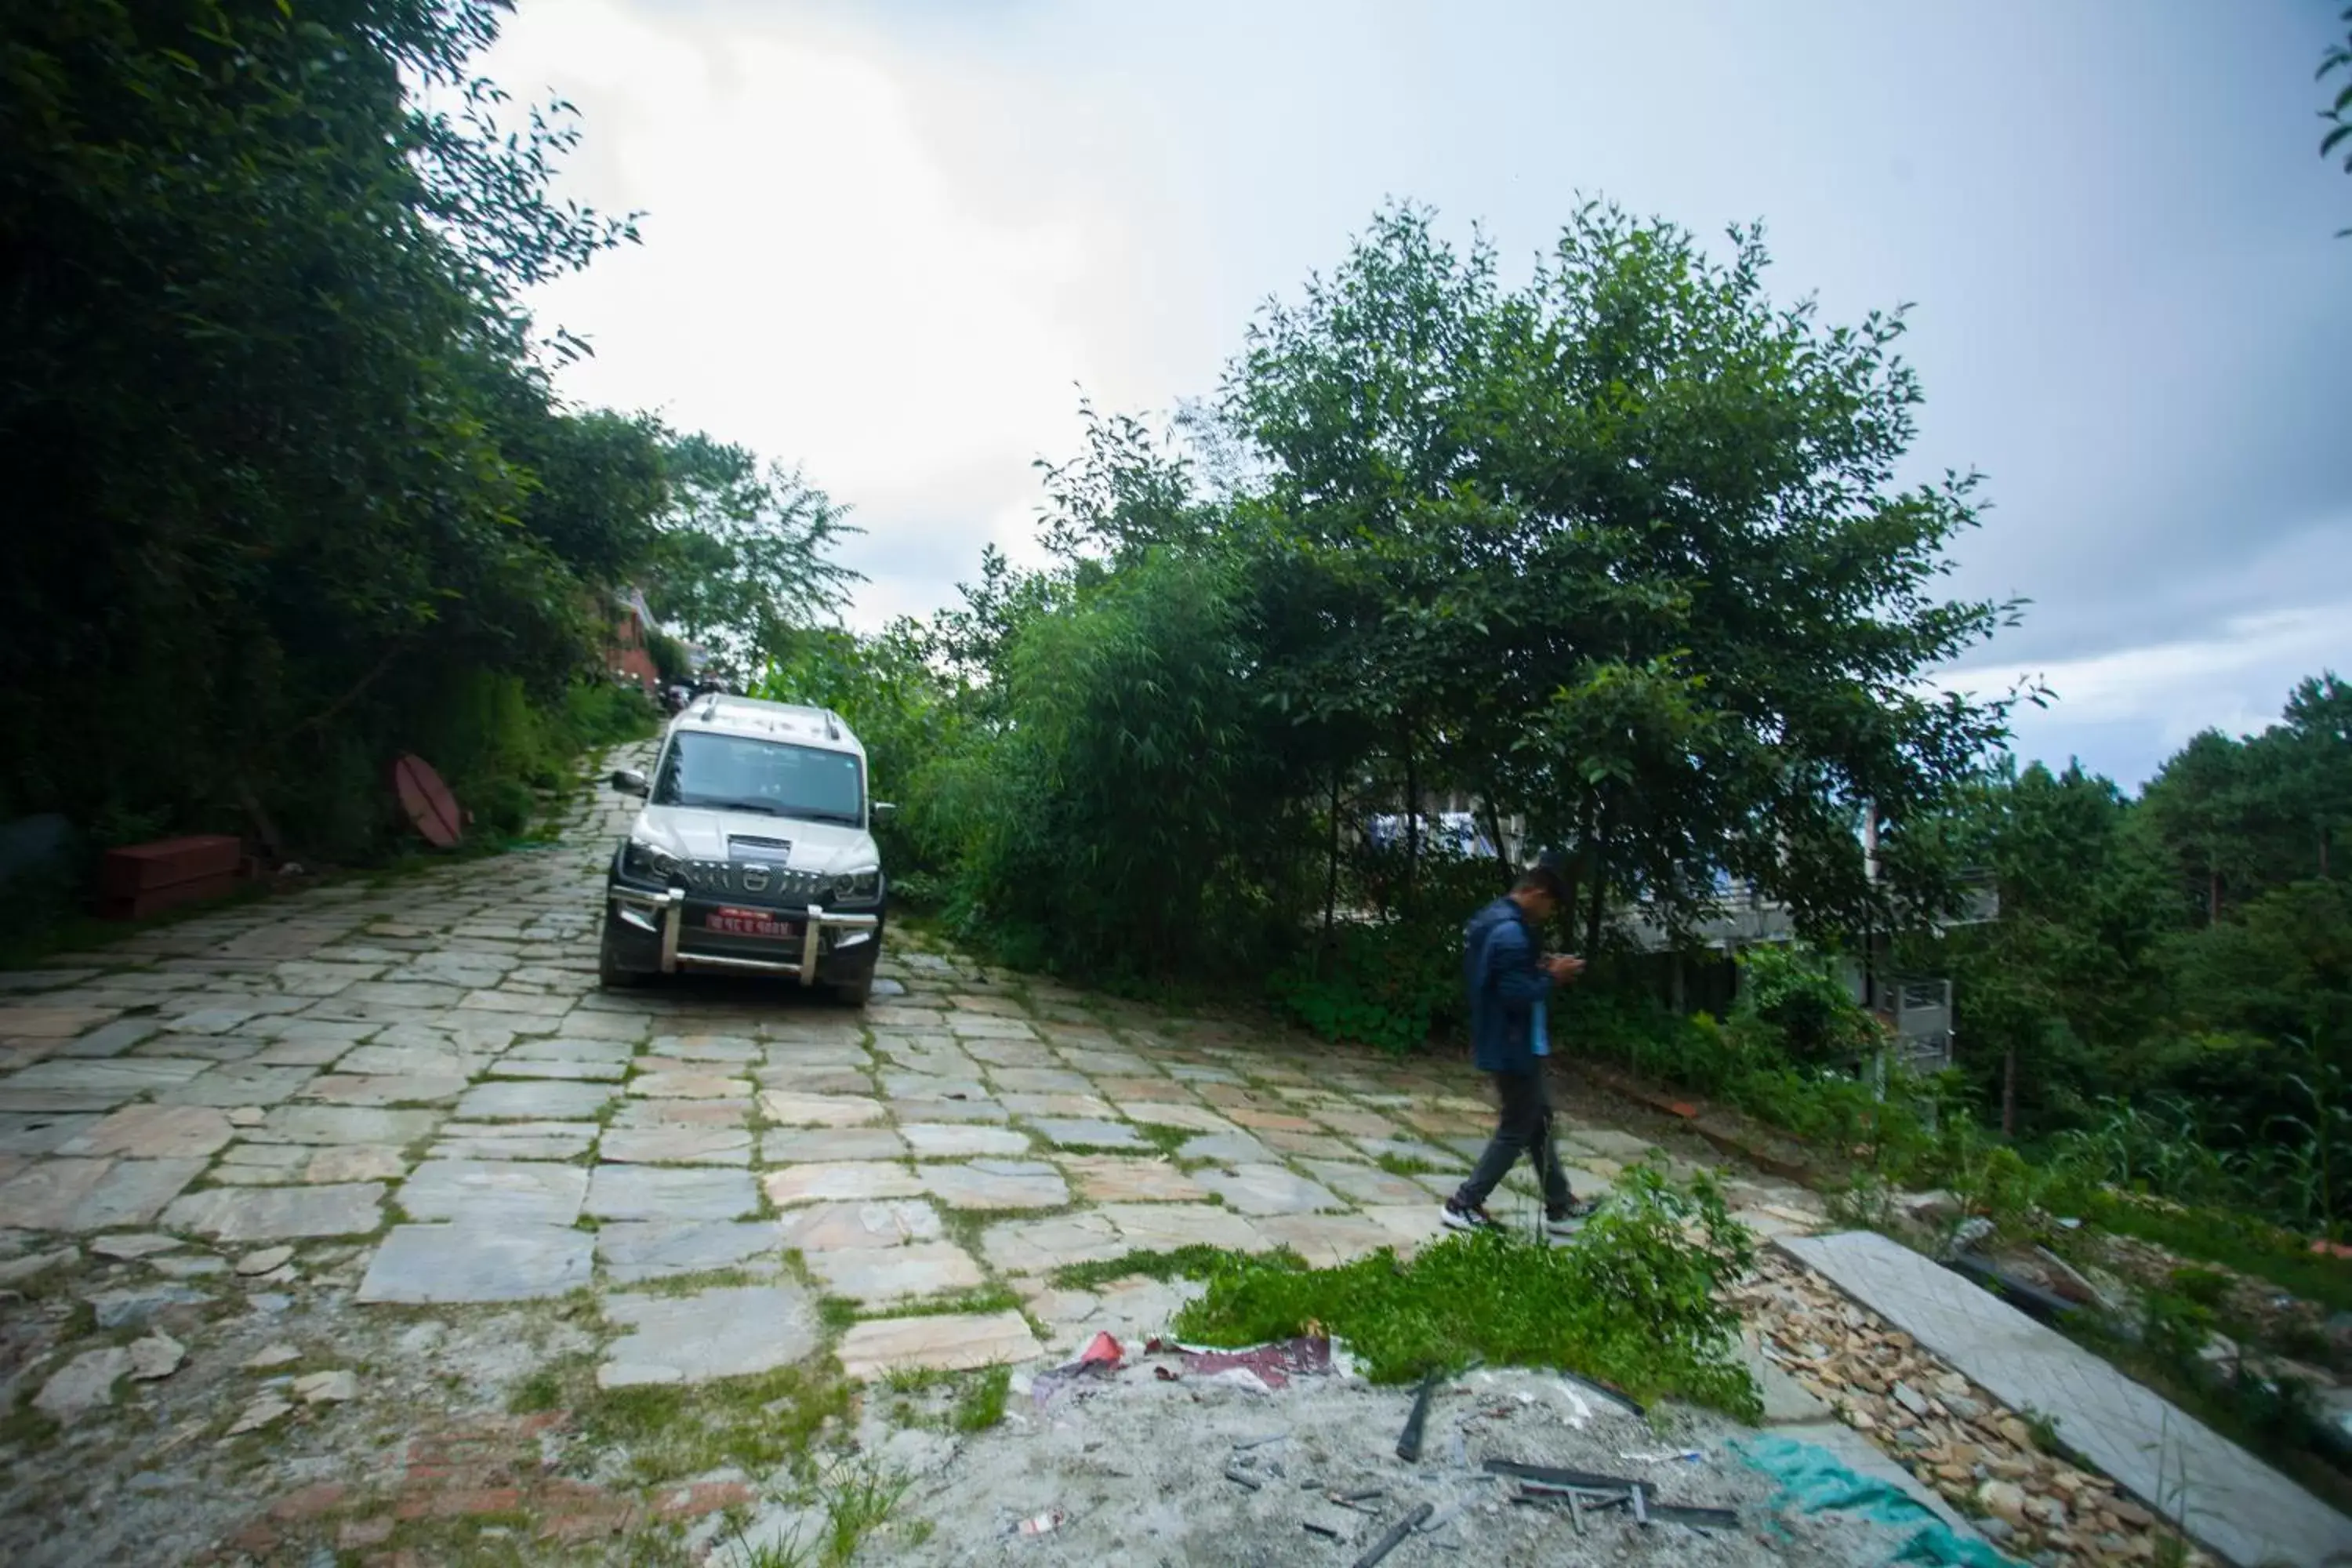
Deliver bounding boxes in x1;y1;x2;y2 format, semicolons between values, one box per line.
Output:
1174;1166;1762;1420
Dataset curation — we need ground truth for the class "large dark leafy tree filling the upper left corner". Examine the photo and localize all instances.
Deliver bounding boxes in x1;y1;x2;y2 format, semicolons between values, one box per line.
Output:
0;0;637;848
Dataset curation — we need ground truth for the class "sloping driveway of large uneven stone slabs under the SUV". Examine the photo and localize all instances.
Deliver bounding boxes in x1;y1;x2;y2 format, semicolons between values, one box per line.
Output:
0;752;1811;1544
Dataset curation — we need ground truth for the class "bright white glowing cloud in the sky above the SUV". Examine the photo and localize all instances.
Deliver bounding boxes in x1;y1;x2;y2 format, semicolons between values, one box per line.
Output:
485;0;1122;623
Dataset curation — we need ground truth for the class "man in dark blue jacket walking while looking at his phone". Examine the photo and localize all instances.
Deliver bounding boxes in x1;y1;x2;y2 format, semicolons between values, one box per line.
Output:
1444;862;1595;1236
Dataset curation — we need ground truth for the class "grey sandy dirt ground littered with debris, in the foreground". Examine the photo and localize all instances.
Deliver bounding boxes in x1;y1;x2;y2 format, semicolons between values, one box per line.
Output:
739;1356;1966;1568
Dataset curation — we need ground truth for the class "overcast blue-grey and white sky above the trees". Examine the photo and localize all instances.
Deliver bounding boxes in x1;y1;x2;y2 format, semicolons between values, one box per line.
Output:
487;0;2352;785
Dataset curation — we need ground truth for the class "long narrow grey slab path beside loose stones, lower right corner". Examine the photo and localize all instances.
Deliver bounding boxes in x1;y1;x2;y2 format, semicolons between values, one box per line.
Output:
1778;1232;2352;1563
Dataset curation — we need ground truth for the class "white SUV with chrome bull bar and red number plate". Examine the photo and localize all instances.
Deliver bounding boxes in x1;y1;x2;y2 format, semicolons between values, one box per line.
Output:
597;696;891;1004
